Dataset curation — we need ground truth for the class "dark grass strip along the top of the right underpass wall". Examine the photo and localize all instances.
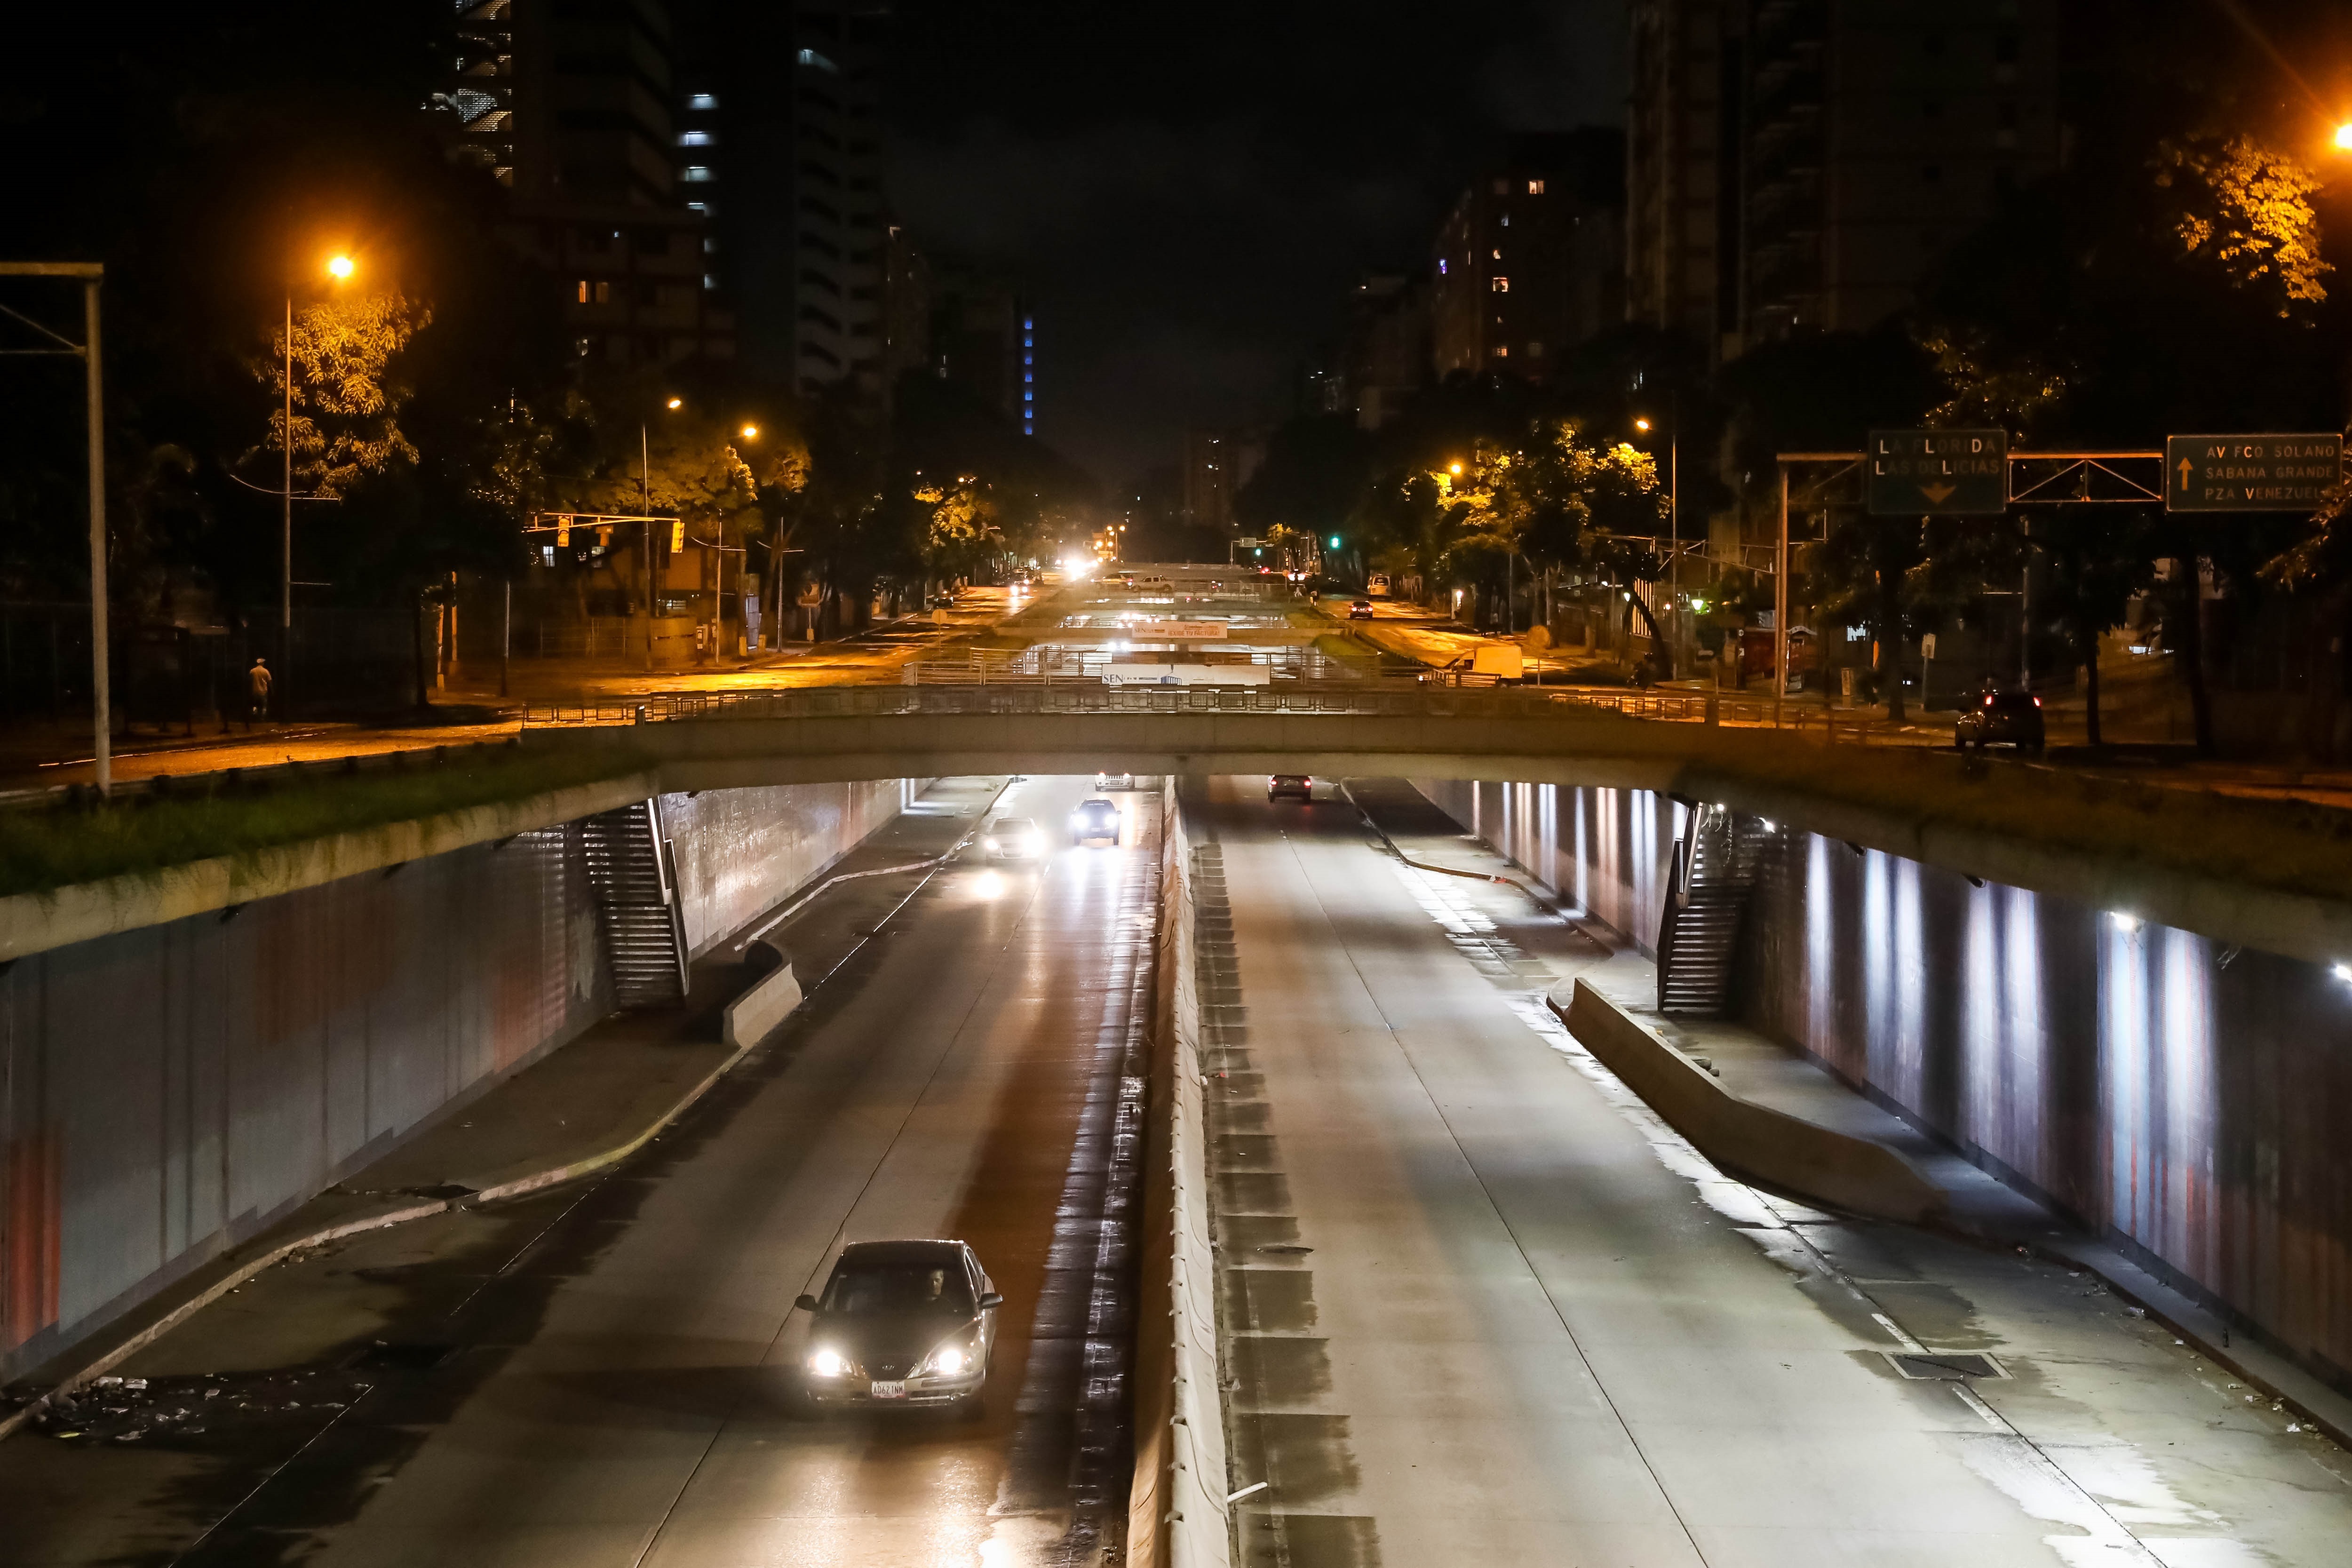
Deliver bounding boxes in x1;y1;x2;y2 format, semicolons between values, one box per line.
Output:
1686;731;2352;900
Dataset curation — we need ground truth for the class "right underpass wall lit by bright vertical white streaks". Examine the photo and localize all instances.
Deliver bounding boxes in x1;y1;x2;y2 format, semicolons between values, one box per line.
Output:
1416;780;2352;1387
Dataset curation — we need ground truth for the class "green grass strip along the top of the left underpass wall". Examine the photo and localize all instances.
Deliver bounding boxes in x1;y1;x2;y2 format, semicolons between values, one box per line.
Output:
0;740;647;896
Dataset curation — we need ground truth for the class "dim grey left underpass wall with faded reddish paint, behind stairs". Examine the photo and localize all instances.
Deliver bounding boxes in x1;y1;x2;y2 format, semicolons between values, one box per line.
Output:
0;778;924;1382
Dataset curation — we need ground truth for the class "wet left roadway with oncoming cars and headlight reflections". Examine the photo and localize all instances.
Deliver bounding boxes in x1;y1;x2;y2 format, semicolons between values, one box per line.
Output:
0;780;1157;1568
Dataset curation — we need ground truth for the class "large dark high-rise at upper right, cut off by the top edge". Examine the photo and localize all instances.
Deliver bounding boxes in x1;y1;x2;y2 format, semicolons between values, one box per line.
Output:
1628;0;2060;360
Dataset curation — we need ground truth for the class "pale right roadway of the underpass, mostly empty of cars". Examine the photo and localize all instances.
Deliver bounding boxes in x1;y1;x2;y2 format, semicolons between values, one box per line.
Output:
1185;778;2352;1568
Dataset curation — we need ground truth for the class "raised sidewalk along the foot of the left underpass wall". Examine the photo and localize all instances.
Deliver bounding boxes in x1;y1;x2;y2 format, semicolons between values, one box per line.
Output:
0;778;1004;1439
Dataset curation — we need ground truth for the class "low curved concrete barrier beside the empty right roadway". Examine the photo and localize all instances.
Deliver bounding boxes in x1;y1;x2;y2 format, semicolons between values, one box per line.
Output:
1550;980;1943;1225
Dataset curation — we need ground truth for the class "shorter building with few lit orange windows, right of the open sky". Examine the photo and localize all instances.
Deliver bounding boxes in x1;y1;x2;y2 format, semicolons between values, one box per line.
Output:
1430;127;1625;383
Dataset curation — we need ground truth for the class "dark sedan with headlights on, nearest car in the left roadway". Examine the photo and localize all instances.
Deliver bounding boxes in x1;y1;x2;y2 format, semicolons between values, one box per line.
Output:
795;1241;1004;1413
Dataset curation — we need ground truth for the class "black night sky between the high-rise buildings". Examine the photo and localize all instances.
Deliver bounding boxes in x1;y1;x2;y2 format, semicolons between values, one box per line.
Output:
889;0;1625;484
